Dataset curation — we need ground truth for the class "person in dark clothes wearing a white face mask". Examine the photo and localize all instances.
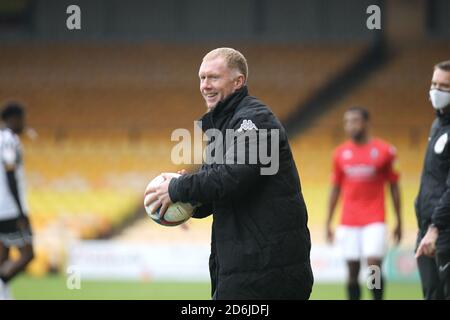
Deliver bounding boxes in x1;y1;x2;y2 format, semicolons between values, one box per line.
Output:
415;60;450;300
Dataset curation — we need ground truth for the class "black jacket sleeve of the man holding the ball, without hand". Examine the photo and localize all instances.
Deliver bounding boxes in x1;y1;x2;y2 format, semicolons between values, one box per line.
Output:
169;119;278;203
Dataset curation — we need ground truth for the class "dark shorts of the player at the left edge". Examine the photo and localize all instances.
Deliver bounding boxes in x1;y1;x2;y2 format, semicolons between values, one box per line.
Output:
0;217;33;248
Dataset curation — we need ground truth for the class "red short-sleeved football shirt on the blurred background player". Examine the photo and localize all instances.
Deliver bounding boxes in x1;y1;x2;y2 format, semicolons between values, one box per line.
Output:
332;139;399;226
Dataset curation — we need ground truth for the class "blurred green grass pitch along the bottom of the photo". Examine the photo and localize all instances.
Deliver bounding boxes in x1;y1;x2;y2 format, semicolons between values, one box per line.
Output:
11;276;422;300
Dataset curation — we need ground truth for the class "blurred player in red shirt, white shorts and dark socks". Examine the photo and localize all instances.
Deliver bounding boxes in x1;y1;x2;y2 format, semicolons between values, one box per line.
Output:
326;107;402;300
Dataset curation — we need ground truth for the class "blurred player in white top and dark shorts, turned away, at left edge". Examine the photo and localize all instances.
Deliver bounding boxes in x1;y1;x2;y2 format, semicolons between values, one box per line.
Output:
0;103;33;299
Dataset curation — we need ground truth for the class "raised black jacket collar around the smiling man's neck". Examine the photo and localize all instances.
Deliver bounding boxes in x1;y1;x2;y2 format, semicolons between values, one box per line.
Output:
199;86;248;131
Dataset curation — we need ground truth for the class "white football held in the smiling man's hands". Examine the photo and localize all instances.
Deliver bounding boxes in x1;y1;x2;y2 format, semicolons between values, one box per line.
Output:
144;173;194;227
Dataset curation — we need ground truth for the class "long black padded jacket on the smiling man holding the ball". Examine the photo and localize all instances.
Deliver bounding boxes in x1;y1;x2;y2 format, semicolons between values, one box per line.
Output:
169;87;313;299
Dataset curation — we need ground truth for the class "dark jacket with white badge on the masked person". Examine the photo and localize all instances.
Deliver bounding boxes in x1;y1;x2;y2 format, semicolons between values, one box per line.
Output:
415;113;450;249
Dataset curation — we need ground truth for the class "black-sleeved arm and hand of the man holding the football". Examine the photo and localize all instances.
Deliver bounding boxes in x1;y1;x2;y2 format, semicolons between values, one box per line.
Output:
147;114;279;212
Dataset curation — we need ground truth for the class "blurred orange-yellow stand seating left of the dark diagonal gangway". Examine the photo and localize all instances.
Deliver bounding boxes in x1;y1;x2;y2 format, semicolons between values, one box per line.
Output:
0;44;364;270
